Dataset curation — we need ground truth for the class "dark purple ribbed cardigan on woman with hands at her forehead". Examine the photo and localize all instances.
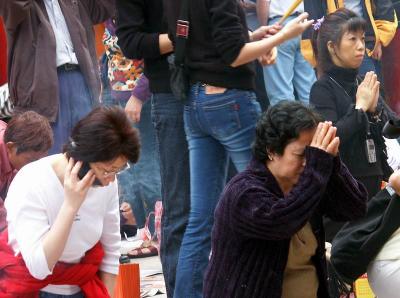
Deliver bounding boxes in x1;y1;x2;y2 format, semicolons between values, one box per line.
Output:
204;147;367;298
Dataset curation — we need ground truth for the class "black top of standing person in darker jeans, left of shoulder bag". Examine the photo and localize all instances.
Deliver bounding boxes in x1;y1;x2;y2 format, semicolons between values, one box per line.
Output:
116;0;171;93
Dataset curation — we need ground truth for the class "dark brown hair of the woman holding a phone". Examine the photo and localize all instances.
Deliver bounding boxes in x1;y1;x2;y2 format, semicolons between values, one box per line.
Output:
63;106;140;163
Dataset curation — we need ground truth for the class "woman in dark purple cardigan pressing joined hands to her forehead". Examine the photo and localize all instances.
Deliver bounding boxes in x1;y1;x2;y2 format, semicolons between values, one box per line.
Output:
204;101;367;298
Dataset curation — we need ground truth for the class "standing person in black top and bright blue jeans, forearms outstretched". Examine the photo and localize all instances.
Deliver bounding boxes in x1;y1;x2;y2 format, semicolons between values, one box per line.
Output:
164;0;312;298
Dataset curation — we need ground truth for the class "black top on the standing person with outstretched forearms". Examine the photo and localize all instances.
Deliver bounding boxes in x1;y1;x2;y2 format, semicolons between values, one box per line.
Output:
164;0;254;90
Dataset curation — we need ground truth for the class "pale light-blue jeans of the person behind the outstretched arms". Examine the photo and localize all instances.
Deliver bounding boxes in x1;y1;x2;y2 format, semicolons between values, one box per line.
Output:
264;16;317;105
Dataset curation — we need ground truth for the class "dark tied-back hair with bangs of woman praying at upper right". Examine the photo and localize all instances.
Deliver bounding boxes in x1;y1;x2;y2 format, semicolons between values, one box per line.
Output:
312;8;367;74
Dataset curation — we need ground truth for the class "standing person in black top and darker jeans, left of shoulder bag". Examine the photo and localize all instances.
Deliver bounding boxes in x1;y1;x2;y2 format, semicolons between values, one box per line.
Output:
116;0;190;297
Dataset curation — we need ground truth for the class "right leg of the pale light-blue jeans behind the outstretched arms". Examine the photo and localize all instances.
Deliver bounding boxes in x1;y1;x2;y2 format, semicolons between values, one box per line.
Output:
293;38;317;104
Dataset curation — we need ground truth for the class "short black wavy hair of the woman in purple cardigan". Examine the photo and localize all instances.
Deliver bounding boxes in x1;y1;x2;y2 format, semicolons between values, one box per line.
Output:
252;101;322;162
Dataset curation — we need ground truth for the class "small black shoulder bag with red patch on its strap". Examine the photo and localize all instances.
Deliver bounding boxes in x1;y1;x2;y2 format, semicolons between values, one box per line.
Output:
168;0;190;101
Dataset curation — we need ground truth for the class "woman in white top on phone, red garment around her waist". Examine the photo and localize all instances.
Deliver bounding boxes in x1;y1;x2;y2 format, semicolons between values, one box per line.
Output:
0;107;140;298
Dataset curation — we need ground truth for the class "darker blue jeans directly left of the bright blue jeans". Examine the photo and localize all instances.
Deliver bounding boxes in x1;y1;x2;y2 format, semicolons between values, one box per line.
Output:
152;93;190;297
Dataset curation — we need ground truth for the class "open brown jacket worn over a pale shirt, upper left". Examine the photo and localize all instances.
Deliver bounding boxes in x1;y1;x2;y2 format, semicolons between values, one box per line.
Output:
0;0;115;121
